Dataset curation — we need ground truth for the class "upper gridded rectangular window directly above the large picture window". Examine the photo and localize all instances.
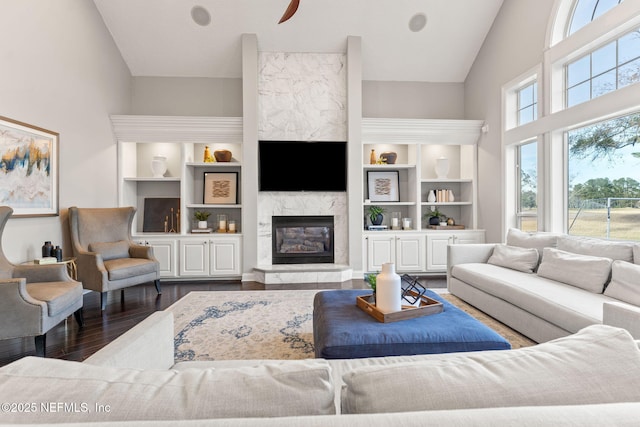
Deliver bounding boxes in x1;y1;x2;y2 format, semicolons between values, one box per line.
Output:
566;29;640;107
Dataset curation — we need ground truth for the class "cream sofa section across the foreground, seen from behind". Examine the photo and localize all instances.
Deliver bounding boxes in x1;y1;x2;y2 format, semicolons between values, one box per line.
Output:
0;312;640;427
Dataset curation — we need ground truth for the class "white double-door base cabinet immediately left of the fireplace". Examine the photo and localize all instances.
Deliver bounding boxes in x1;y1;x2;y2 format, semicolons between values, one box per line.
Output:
180;235;242;277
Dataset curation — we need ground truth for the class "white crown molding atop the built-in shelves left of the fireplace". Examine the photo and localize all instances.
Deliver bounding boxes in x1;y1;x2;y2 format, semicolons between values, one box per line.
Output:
111;115;242;143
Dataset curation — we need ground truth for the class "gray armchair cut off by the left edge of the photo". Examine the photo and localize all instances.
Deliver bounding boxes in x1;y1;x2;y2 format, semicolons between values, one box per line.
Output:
0;206;84;357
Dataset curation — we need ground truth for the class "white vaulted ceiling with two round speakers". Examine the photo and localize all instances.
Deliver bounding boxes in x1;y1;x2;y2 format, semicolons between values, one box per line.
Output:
94;0;503;82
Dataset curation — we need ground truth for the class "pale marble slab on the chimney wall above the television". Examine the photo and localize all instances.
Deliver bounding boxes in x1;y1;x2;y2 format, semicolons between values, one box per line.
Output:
258;52;347;141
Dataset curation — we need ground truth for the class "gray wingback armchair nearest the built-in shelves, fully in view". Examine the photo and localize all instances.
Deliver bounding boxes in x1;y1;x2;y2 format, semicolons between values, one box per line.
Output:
69;206;161;310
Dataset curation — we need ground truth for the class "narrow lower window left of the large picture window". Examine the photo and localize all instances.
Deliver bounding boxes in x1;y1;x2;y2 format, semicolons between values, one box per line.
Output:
516;141;538;231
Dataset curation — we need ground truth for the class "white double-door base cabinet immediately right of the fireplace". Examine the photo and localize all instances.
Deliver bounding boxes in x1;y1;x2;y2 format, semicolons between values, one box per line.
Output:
366;232;425;272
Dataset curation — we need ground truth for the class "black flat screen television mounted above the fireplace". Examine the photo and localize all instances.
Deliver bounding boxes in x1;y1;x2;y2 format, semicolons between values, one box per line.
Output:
258;141;347;191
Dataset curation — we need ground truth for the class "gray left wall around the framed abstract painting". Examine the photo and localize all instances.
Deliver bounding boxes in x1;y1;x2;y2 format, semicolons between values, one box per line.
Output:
0;0;131;263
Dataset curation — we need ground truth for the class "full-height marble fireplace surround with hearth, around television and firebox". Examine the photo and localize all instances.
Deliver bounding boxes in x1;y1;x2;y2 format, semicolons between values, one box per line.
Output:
255;52;351;283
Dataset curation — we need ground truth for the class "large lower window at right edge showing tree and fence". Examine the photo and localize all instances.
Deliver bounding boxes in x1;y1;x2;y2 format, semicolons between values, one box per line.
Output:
567;113;640;240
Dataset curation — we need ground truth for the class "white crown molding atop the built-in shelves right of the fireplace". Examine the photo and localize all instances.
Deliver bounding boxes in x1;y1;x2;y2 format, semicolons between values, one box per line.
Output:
362;118;484;145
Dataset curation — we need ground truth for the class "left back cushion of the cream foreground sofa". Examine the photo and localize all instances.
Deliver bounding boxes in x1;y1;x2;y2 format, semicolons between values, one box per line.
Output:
0;357;335;423
